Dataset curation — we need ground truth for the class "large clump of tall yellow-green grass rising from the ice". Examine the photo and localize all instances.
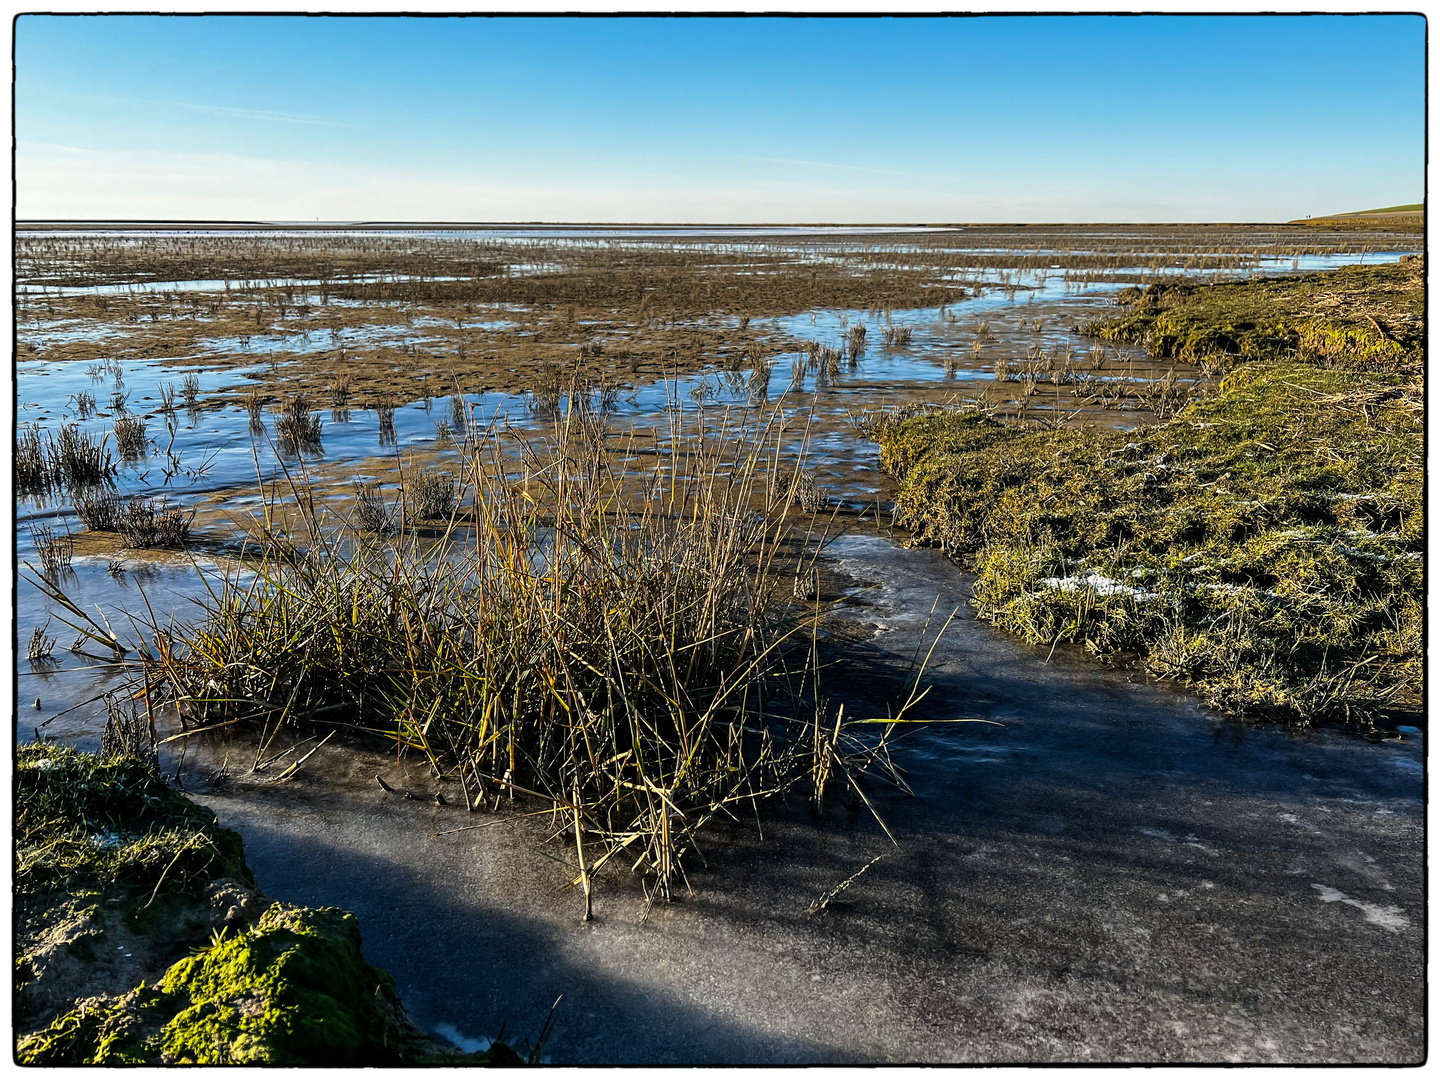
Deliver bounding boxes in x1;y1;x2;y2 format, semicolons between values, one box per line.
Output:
143;413;910;896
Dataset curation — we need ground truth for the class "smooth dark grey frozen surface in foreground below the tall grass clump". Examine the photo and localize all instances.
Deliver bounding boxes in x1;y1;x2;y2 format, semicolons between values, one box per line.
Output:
185;539;1424;1064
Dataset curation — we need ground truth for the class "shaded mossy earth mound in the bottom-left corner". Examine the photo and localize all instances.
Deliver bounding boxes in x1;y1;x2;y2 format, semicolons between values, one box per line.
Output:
14;743;520;1066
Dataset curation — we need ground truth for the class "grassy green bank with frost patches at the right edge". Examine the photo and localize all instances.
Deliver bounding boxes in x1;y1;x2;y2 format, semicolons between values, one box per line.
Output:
881;264;1424;727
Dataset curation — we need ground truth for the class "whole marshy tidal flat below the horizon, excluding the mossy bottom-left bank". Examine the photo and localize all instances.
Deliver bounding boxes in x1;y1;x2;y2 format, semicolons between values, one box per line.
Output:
14;225;1424;1064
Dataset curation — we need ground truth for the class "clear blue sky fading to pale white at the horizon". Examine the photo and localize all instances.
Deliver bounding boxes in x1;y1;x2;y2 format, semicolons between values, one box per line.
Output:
16;16;1426;223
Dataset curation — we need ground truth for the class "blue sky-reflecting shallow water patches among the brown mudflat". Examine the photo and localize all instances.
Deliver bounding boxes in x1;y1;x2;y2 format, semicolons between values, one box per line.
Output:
14;243;1422;739
